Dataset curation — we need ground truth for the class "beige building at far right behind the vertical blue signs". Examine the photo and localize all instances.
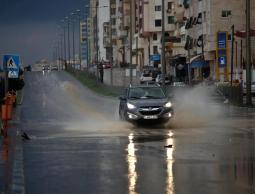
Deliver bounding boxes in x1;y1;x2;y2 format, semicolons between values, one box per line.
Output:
184;0;255;81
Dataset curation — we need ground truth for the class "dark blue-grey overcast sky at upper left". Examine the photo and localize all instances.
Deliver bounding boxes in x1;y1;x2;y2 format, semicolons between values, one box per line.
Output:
0;0;88;65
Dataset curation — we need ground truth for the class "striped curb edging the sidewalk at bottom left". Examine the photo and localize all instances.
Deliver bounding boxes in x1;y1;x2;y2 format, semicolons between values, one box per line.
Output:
10;130;25;194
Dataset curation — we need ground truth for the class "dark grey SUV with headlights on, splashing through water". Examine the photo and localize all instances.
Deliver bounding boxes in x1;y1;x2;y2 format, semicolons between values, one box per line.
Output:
119;85;173;122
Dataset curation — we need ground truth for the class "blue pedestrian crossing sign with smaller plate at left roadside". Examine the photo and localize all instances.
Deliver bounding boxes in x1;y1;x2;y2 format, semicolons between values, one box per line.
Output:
3;55;20;78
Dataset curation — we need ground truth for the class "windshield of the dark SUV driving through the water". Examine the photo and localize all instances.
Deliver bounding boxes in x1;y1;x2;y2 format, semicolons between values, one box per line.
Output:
129;87;166;99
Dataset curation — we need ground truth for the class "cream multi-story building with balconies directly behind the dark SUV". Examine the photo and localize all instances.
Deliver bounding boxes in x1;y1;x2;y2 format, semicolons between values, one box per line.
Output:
133;0;186;79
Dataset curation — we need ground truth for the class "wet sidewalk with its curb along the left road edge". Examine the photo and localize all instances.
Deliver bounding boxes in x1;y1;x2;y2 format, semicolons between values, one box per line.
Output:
0;104;25;194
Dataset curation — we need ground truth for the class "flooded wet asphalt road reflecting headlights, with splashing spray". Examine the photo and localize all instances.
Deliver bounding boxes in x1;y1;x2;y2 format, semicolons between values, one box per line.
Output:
21;72;255;194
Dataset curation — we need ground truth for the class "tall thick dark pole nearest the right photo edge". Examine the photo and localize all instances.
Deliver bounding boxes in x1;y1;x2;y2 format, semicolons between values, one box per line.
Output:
246;0;252;107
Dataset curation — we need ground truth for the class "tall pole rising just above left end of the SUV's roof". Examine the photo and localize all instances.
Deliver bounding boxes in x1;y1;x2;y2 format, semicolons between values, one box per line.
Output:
129;0;133;84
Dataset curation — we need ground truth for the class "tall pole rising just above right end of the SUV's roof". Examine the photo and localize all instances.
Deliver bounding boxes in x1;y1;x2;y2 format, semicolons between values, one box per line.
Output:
161;0;166;90
